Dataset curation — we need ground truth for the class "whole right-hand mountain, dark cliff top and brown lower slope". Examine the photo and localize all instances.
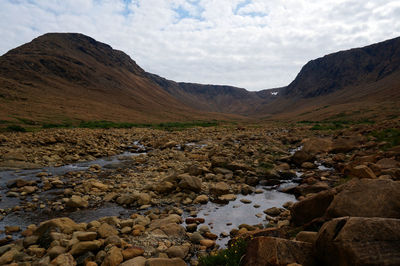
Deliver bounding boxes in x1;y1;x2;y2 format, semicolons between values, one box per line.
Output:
258;37;400;119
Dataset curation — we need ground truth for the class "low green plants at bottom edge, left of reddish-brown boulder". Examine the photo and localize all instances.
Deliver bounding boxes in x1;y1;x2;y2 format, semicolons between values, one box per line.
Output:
199;239;248;266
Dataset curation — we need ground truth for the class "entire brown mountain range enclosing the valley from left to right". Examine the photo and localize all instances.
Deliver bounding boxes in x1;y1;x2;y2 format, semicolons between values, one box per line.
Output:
0;33;400;123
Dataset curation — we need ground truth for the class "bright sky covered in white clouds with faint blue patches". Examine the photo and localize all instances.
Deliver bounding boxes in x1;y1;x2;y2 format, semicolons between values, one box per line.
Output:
0;0;400;90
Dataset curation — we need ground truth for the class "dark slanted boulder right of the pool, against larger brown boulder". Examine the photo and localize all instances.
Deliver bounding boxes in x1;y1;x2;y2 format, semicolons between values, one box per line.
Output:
290;190;335;226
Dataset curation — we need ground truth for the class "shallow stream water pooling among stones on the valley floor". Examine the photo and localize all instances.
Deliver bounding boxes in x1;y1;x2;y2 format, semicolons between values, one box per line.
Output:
0;143;322;247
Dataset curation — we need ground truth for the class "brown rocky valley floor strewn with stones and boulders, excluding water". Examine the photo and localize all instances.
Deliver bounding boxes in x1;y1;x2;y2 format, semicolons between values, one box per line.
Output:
0;121;400;266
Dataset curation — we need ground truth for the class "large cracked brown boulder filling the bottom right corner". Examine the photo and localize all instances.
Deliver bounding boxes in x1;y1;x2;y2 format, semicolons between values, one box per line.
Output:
315;217;400;266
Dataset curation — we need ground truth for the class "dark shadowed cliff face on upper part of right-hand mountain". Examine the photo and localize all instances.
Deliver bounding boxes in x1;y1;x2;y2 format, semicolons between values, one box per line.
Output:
283;37;400;98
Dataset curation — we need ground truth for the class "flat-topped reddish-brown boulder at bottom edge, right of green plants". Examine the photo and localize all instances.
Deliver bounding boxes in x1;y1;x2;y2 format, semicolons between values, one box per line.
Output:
243;237;313;266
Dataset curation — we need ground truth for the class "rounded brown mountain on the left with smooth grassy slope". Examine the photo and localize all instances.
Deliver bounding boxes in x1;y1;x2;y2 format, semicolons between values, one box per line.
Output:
0;33;234;122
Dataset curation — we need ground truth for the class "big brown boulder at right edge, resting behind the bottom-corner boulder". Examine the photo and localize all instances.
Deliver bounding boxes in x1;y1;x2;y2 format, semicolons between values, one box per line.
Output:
327;179;400;218
